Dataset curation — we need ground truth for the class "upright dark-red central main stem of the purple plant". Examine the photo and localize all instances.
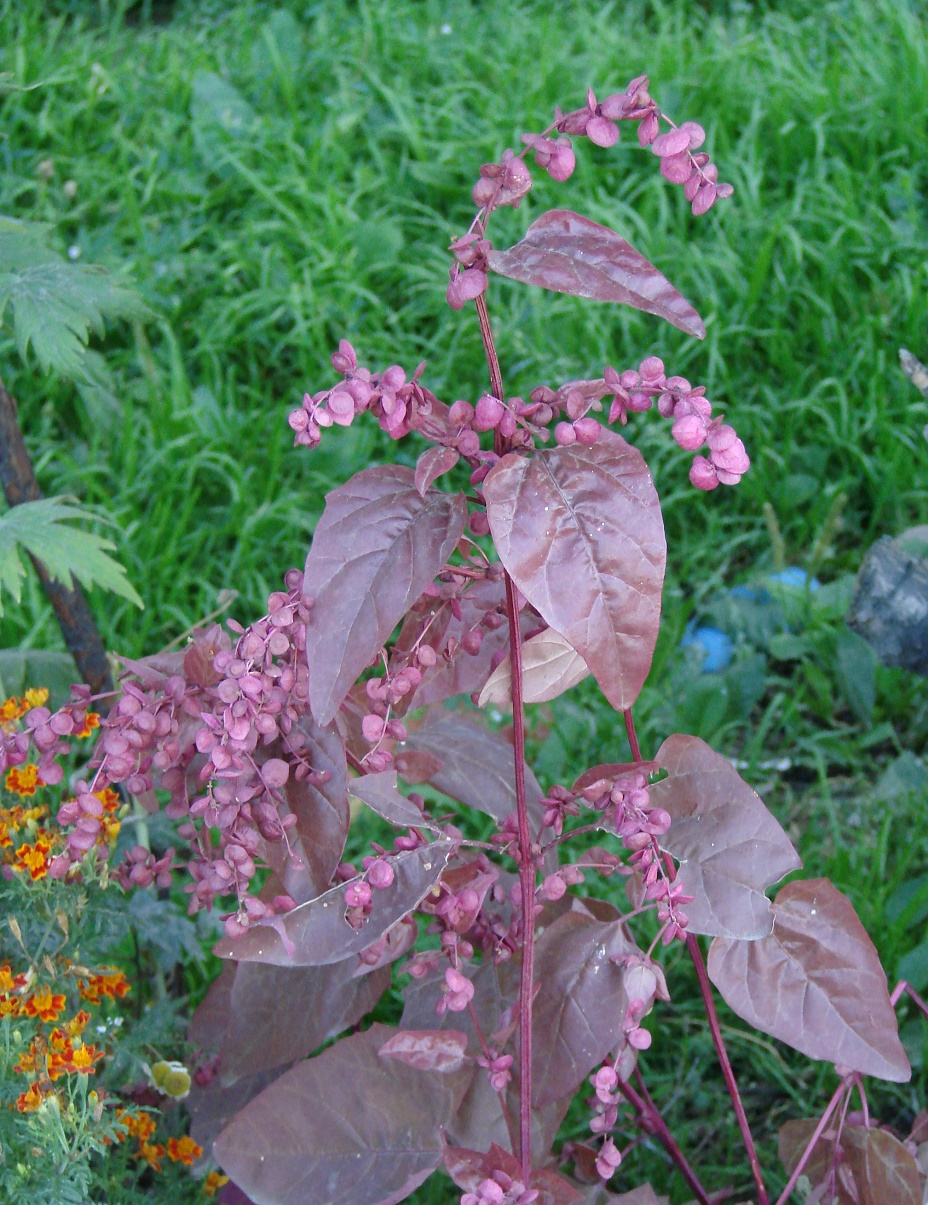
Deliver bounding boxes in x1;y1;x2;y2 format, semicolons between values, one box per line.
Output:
476;289;535;1185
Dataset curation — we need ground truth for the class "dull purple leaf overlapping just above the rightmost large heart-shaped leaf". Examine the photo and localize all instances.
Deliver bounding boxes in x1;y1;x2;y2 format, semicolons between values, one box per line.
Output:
651;735;801;940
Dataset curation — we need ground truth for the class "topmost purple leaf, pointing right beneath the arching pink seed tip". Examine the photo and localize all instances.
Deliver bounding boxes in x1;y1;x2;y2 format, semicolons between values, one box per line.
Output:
487;210;706;339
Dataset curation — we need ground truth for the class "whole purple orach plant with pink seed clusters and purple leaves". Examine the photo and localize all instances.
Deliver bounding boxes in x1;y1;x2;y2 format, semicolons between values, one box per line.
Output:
21;77;926;1205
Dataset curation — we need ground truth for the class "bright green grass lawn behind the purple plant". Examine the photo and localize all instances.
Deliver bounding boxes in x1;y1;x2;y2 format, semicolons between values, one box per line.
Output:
0;0;928;1201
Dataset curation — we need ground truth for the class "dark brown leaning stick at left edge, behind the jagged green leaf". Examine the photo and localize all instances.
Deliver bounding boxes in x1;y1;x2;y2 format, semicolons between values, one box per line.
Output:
0;382;113;694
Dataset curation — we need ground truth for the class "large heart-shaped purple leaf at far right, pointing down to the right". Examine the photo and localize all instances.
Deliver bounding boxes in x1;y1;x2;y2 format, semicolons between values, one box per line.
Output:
709;878;911;1083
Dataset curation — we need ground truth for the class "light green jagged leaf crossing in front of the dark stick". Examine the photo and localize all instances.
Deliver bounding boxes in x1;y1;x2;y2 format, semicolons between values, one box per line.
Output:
0;498;143;615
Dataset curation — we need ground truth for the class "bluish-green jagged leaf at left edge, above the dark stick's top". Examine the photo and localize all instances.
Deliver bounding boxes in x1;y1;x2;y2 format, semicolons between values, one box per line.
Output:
0;260;147;377
